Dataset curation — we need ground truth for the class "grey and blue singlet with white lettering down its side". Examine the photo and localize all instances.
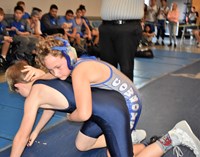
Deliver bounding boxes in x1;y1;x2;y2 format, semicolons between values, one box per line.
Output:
74;57;142;131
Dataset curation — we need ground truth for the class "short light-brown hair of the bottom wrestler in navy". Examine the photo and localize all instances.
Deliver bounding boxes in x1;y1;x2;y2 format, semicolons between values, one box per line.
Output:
5;60;28;92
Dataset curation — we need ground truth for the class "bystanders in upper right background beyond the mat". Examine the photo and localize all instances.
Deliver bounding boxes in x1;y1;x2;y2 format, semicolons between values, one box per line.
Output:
141;0;200;47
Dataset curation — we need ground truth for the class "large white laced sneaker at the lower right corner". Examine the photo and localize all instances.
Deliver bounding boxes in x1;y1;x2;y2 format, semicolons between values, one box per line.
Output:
168;120;200;157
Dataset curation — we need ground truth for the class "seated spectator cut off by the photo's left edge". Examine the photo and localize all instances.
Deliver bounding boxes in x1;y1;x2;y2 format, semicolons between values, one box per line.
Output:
0;8;12;71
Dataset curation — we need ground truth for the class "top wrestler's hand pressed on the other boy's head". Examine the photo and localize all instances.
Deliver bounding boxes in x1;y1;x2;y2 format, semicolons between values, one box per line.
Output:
21;65;45;81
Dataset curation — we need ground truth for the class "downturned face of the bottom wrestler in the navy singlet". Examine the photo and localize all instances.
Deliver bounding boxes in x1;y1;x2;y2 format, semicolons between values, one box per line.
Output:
14;83;31;97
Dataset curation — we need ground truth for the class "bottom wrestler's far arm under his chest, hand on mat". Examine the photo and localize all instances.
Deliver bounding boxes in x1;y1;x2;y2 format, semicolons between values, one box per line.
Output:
27;110;55;146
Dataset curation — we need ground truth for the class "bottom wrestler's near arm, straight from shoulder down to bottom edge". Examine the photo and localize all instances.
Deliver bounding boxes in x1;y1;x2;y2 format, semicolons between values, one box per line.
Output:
10;87;40;157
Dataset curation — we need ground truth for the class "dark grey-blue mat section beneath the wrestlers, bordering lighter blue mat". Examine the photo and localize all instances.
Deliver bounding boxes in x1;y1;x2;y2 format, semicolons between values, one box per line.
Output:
0;61;200;157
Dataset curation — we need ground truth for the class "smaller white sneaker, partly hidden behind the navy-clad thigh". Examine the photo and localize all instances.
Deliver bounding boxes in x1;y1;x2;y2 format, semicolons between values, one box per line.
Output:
131;130;147;144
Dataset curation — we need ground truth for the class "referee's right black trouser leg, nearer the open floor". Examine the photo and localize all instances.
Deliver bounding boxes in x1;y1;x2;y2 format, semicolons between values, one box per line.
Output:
113;20;142;81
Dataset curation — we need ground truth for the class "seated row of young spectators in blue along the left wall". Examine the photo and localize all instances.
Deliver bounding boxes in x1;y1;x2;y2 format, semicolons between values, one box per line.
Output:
0;1;99;72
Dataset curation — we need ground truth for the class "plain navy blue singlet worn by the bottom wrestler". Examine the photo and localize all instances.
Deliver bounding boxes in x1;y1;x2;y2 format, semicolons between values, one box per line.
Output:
34;79;133;157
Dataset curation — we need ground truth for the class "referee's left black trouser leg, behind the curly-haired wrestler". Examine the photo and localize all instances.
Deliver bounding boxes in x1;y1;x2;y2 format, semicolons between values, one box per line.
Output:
99;23;118;68
